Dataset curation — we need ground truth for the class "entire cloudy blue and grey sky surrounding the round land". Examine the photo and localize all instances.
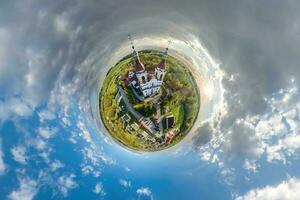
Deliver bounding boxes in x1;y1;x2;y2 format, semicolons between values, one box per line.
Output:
0;0;300;200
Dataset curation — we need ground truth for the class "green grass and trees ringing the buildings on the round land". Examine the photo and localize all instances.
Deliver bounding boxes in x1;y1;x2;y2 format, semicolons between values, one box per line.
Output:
99;50;200;151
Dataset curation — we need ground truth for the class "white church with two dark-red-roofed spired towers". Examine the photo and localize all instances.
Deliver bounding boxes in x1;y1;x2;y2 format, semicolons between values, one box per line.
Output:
124;46;168;100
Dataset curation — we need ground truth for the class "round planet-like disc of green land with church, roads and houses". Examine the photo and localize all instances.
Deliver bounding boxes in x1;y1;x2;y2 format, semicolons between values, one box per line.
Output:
99;50;200;151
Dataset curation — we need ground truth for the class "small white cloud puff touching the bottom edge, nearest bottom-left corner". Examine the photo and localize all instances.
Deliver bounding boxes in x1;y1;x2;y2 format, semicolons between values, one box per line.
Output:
8;178;38;200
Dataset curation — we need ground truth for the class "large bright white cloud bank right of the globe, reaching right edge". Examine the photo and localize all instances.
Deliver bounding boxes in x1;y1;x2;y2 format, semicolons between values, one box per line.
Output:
194;80;300;172
